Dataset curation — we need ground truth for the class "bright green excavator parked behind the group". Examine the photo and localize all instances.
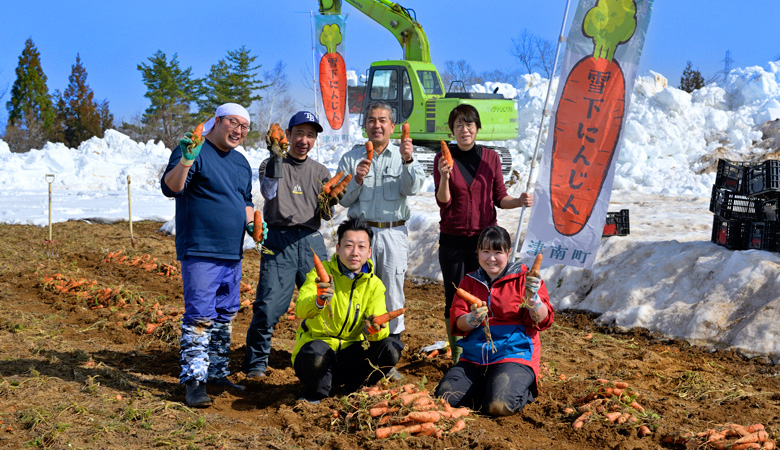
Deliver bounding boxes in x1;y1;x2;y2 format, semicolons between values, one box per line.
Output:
319;0;518;177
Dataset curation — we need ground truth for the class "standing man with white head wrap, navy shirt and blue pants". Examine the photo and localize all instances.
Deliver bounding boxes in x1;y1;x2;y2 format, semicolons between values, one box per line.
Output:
160;103;262;407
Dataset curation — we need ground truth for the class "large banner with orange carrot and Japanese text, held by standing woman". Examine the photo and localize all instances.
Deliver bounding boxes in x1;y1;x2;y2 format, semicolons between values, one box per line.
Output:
521;0;652;268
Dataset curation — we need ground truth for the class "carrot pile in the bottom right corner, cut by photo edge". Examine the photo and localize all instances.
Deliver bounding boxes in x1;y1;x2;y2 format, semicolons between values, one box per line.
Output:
661;423;777;450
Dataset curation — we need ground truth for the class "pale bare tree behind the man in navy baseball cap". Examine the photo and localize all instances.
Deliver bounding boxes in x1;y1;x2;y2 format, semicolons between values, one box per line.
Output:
256;61;302;141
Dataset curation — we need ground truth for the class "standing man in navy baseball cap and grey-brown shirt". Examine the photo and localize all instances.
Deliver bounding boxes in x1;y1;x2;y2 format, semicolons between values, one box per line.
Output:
242;111;339;379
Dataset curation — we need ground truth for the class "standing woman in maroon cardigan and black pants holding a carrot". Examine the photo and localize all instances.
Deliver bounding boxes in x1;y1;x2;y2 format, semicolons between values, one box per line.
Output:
433;104;533;362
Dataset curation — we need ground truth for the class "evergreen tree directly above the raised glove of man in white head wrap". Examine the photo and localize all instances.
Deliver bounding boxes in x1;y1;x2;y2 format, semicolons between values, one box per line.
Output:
137;50;200;148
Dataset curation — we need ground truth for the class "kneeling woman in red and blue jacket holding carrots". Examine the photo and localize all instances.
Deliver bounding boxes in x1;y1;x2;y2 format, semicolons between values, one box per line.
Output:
435;226;555;416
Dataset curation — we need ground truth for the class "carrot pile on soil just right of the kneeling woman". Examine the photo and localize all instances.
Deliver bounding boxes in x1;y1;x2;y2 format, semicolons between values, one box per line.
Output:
563;378;657;437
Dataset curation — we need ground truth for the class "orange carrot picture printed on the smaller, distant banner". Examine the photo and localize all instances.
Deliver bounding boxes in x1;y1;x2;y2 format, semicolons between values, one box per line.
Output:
320;23;347;130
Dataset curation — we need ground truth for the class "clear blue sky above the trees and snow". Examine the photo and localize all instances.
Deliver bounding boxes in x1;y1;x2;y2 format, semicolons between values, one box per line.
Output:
0;0;780;124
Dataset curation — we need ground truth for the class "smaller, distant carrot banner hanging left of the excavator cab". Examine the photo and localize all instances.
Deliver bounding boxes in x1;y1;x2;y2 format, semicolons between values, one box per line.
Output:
314;15;349;144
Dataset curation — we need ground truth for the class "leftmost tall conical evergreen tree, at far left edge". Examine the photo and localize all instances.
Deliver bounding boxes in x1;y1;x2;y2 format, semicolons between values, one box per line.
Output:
6;38;55;151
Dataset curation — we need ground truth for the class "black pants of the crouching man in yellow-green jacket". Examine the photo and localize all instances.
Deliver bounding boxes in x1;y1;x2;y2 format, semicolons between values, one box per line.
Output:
293;337;404;400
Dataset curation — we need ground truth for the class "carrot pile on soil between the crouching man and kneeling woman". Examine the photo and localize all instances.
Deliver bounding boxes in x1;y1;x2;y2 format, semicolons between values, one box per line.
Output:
333;379;470;439
